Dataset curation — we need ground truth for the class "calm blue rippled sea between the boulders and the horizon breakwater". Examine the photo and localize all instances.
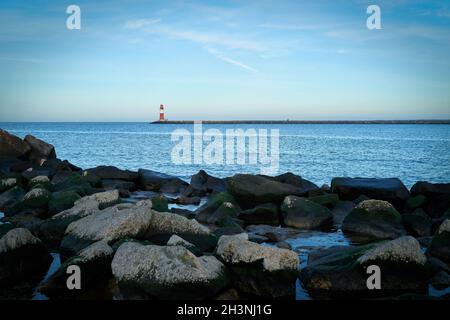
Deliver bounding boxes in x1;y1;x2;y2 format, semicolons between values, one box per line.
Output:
0;123;450;187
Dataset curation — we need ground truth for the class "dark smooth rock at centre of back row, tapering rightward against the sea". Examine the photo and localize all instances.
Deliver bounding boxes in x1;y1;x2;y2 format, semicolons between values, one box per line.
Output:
228;174;308;209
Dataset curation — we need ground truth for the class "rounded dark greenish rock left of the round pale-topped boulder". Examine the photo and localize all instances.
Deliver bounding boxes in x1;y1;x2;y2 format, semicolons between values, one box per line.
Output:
280;196;333;229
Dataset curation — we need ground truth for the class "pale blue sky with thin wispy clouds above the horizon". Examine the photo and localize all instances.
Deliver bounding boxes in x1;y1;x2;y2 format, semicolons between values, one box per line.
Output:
0;0;450;121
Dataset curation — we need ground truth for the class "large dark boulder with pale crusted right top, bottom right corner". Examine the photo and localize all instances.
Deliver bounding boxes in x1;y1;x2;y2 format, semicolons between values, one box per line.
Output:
300;236;428;298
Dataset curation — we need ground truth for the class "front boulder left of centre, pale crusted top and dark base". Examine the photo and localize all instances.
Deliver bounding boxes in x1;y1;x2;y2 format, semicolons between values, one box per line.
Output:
111;242;229;299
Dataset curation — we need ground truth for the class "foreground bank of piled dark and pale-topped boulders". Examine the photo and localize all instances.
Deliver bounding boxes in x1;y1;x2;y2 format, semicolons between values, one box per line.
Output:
0;130;450;299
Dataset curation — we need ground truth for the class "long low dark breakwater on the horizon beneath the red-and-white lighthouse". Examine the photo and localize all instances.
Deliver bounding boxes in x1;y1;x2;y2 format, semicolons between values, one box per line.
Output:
150;120;450;124
